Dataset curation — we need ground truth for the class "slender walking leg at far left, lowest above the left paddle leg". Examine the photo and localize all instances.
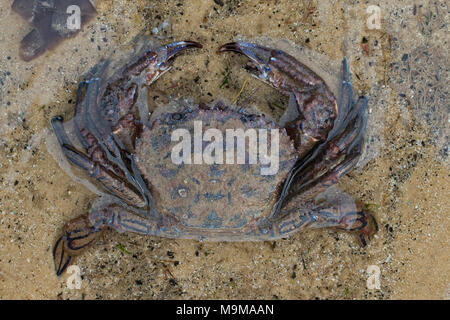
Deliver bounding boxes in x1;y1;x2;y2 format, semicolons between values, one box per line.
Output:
52;117;146;207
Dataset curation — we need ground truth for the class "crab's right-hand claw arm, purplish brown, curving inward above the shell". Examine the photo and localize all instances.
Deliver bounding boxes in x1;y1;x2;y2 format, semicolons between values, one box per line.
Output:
219;42;338;158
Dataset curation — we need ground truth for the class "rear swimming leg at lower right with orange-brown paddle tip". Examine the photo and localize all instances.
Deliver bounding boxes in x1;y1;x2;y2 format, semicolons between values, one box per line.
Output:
273;203;378;246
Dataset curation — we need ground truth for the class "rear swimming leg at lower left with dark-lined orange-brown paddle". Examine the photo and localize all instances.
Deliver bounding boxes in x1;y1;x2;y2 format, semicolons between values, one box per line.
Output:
53;205;163;276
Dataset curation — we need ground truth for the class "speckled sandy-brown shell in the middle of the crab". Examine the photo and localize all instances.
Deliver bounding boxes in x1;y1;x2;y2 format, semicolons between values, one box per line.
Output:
135;104;297;240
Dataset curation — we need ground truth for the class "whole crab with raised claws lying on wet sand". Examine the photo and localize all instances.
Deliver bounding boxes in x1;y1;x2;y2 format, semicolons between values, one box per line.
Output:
51;35;377;276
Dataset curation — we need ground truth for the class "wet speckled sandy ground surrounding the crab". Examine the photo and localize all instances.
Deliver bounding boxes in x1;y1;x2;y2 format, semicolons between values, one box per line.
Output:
0;0;450;299
